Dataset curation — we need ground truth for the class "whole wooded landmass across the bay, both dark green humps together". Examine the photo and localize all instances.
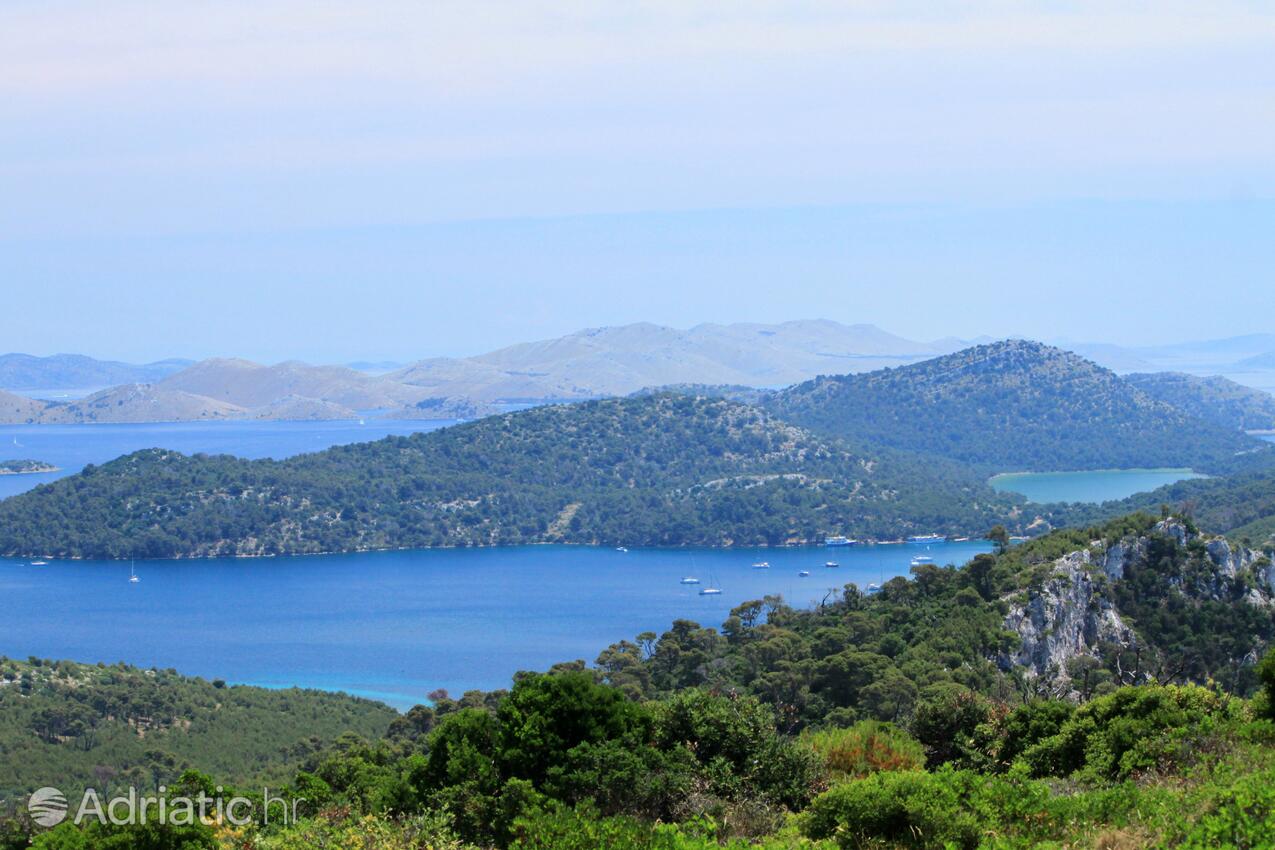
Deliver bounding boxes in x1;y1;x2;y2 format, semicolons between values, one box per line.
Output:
0;340;1275;558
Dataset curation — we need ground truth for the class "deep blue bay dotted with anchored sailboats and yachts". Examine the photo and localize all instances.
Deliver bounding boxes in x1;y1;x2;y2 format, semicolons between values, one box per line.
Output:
0;542;988;707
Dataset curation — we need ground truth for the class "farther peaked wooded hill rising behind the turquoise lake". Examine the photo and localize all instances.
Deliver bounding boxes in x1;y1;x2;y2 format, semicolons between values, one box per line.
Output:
764;340;1262;472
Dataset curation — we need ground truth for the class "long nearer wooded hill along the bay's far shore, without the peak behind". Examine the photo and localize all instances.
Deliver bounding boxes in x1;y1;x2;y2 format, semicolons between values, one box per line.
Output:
0;395;1015;558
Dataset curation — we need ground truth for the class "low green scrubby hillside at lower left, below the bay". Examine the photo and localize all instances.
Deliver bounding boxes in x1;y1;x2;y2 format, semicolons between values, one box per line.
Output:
0;658;397;799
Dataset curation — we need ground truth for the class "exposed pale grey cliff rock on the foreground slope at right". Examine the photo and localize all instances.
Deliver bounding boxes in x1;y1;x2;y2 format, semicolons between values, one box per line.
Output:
998;519;1275;693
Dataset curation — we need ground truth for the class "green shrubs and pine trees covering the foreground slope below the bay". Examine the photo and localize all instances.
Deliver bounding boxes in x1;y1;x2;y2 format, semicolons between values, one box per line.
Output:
7;515;1275;850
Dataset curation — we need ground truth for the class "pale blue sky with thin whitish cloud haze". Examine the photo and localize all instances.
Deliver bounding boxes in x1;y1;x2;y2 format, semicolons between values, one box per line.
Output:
0;0;1275;362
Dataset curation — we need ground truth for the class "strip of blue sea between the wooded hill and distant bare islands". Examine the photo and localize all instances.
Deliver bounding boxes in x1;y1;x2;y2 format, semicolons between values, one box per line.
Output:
0;419;451;498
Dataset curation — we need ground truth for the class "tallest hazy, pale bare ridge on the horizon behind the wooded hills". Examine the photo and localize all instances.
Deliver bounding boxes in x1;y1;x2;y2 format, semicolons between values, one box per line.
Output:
389;320;959;401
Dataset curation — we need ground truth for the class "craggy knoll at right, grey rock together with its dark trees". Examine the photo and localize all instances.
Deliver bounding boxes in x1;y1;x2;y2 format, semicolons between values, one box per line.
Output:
1000;517;1275;696
